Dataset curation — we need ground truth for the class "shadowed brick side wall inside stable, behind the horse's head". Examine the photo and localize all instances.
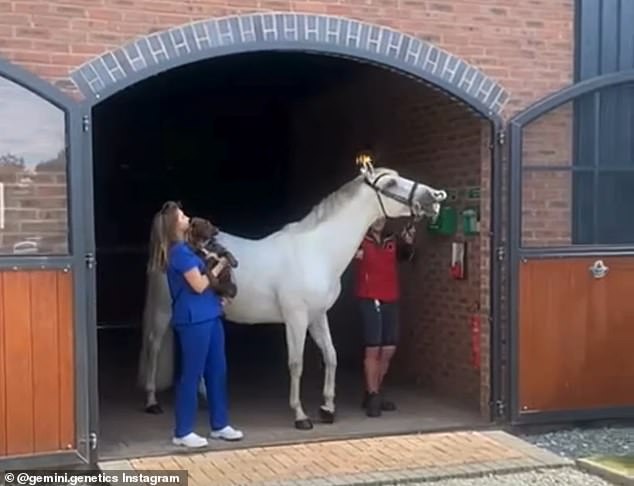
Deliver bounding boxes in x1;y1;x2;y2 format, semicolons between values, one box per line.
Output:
282;71;490;406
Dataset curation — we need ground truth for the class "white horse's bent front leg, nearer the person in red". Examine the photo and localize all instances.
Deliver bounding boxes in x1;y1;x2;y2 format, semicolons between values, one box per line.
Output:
308;312;337;424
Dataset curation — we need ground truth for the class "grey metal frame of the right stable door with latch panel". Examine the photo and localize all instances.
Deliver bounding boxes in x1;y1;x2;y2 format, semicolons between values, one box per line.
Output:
506;69;634;425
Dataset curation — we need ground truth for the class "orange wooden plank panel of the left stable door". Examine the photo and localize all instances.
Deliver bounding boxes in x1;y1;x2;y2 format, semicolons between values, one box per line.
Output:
0;270;75;456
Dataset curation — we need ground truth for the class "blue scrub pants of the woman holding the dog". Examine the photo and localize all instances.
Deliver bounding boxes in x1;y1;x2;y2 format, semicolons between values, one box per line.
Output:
174;318;229;437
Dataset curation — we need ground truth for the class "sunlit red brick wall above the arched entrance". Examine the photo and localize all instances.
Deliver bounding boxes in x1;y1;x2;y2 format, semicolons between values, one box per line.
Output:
0;0;574;117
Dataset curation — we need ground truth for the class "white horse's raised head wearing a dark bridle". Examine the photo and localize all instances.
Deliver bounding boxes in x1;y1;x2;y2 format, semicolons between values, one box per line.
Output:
362;168;447;220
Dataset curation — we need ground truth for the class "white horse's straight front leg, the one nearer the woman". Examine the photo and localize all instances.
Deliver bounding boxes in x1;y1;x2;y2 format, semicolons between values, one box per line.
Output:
284;311;313;430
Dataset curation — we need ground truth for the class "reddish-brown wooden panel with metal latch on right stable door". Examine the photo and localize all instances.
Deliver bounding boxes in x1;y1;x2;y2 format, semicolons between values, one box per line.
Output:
518;257;634;412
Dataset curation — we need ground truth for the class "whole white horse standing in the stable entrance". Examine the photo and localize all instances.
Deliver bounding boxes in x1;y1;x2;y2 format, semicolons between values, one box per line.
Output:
139;166;447;430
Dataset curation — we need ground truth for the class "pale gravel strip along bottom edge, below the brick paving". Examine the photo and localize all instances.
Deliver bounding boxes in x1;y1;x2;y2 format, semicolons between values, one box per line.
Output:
401;467;614;486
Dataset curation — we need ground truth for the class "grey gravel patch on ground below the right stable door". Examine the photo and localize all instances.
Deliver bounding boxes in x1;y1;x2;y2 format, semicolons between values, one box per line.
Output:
518;426;634;459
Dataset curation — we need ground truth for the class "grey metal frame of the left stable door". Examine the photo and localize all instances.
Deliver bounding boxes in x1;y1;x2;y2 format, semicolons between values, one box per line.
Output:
0;59;95;469
